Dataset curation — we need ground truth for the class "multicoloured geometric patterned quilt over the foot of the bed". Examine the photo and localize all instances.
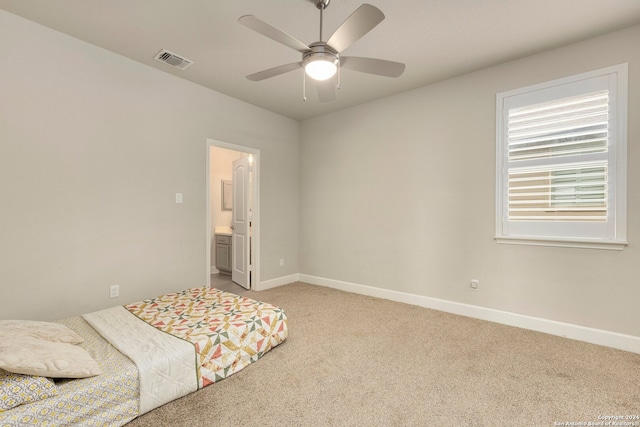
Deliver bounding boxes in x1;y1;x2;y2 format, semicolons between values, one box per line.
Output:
125;288;288;388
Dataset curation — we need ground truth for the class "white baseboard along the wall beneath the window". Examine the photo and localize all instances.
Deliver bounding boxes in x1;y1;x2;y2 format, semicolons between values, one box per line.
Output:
300;274;640;353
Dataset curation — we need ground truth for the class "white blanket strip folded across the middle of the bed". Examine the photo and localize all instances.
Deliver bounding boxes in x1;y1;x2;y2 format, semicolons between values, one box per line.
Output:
82;306;198;415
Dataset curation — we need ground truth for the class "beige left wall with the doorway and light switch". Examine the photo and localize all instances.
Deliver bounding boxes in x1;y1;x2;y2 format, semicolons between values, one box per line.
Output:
0;11;299;319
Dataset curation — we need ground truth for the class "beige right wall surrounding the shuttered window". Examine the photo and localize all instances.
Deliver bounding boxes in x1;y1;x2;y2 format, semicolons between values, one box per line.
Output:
300;26;640;336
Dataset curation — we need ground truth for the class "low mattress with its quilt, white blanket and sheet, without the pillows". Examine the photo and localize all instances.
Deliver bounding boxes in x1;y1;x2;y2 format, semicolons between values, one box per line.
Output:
0;288;288;427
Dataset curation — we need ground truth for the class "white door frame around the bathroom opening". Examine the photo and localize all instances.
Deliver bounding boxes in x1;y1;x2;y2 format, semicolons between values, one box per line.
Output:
205;138;260;290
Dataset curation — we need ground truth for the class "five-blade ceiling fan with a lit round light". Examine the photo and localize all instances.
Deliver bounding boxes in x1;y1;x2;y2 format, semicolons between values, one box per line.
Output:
238;0;405;102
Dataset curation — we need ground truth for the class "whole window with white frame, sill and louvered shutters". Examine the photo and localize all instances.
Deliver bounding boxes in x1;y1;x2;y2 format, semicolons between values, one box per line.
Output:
496;64;627;249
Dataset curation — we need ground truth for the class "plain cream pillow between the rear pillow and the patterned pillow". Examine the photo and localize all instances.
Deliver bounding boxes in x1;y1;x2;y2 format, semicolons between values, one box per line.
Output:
0;337;102;378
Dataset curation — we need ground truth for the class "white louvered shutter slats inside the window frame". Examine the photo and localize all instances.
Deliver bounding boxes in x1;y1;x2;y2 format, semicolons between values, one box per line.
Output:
508;90;609;221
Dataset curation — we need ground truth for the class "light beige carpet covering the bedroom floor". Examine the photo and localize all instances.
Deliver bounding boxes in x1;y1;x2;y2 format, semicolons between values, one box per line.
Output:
128;283;640;427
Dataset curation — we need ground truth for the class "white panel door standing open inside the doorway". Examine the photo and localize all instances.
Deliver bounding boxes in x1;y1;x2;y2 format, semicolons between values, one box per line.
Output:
231;156;251;289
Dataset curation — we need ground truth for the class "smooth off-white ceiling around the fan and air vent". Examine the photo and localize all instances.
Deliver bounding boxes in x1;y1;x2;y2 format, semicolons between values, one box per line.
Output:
0;0;640;120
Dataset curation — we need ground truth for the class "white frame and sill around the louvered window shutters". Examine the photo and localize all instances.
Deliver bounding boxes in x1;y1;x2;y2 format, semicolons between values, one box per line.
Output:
495;63;628;250
